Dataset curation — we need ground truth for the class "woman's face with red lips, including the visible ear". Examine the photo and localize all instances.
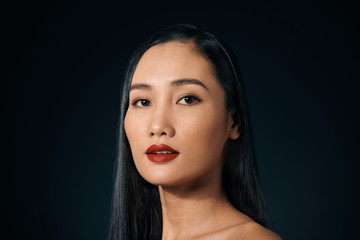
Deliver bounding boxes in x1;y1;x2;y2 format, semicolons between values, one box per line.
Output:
125;41;239;186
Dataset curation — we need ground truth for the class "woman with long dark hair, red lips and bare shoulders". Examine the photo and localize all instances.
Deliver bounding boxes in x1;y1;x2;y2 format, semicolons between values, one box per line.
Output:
110;24;280;240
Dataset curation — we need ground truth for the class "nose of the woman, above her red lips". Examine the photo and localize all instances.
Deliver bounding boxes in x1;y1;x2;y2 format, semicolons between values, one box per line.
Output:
148;108;175;137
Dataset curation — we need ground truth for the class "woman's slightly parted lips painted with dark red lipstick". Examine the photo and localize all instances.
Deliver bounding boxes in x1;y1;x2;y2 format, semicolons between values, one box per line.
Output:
146;144;180;163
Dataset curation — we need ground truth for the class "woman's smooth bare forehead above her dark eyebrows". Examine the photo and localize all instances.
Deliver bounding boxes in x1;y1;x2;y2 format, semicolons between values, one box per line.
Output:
132;41;214;83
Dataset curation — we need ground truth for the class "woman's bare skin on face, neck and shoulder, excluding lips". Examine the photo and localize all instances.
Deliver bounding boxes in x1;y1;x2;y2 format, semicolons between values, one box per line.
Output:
124;41;280;239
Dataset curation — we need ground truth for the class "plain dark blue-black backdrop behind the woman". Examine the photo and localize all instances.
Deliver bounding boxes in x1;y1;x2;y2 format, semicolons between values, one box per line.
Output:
0;0;360;240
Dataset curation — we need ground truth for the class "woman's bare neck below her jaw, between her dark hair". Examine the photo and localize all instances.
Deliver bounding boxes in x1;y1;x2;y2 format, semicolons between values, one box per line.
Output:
159;164;231;239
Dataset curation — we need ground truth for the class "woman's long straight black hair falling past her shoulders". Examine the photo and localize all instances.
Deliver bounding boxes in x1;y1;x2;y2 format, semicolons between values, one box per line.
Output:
109;24;265;240
